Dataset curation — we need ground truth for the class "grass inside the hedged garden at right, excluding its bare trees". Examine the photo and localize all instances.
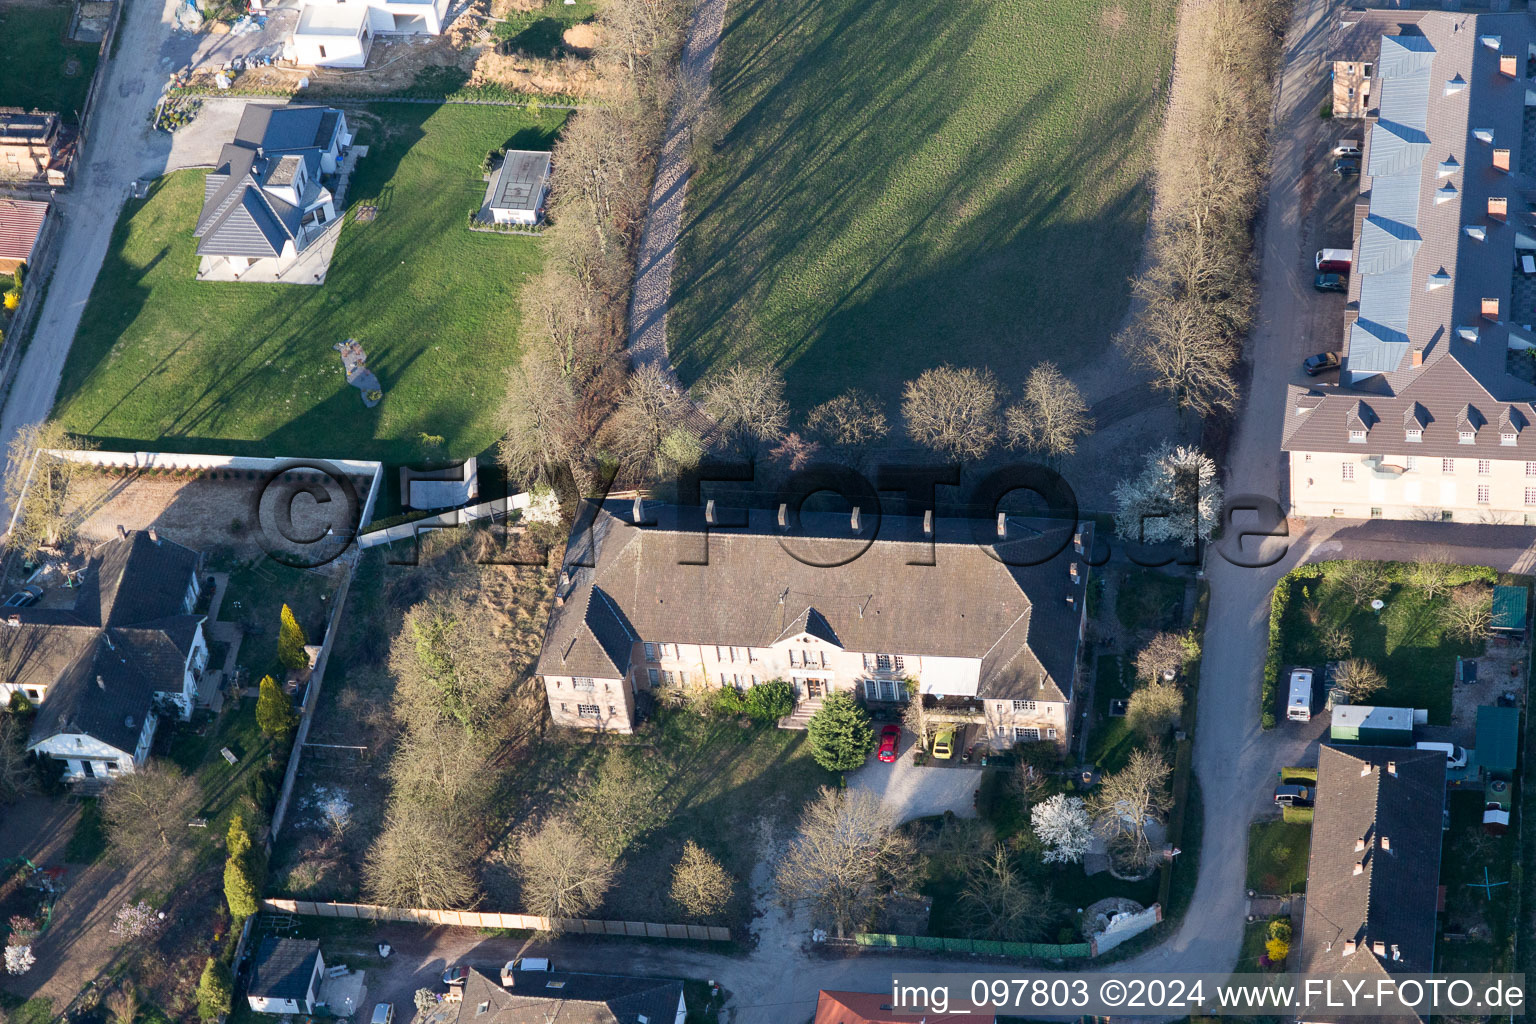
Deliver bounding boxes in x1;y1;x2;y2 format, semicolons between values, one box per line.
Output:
1276;579;1484;725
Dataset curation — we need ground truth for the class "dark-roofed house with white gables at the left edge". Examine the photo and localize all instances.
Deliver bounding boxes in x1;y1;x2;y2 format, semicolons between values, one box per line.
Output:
10;530;207;781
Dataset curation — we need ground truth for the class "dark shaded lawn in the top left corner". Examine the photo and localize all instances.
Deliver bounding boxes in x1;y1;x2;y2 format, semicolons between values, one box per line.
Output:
0;5;100;121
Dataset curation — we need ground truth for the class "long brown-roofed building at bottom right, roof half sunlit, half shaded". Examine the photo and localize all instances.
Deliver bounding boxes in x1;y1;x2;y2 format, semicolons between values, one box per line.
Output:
1293;746;1445;1021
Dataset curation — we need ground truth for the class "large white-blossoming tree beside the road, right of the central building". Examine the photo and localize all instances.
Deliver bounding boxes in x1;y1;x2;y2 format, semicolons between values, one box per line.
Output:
1115;444;1221;547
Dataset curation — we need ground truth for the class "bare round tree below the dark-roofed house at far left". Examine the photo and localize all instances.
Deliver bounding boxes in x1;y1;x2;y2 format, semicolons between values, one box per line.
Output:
101;760;203;870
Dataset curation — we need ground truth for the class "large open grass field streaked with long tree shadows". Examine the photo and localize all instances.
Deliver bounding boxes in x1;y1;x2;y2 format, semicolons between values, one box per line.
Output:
668;0;1177;408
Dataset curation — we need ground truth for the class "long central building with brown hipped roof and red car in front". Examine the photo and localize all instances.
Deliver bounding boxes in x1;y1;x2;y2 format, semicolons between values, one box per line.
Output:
538;499;1092;748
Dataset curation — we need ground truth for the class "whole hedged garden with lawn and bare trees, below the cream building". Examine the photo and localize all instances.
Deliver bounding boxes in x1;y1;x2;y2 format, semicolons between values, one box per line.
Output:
1261;560;1498;728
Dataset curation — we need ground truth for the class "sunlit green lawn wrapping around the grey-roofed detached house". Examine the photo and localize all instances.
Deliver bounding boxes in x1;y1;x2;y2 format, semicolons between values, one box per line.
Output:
55;104;562;462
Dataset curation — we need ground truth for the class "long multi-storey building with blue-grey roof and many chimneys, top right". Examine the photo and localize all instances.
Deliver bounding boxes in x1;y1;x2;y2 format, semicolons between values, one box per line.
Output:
1283;11;1536;525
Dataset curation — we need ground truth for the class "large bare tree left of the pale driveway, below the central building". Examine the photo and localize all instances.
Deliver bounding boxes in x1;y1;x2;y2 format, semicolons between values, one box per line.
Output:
774;788;915;938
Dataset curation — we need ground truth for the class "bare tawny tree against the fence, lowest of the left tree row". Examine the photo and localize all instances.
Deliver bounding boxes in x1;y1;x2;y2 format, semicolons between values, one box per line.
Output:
362;801;478;910
